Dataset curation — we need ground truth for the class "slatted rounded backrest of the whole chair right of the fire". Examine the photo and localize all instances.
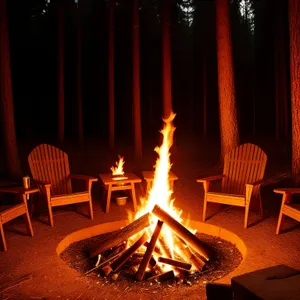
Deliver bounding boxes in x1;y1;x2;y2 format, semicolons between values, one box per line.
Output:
222;144;267;195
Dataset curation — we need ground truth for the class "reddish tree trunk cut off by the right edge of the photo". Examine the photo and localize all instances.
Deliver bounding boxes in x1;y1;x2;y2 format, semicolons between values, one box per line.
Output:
289;0;300;184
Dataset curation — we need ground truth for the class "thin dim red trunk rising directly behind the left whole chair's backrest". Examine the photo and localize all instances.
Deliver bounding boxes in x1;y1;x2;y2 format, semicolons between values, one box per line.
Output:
58;6;65;143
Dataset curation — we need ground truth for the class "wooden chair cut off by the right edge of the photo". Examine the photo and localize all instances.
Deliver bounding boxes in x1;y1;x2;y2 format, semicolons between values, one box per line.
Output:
274;188;300;234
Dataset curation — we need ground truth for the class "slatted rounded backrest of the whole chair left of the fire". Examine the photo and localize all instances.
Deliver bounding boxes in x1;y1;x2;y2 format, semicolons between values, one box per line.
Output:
28;144;72;195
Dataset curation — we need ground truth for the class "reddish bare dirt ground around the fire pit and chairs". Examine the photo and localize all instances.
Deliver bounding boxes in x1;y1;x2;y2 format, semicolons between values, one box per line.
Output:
0;139;300;300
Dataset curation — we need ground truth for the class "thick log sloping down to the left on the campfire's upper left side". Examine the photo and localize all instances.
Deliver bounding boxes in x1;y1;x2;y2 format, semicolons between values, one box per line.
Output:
89;213;150;257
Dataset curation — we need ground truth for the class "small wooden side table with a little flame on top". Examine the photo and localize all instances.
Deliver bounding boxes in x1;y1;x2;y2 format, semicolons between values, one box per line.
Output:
99;173;142;213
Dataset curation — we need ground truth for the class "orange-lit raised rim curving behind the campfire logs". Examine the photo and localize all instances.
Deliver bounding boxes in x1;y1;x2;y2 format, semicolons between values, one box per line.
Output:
56;220;247;277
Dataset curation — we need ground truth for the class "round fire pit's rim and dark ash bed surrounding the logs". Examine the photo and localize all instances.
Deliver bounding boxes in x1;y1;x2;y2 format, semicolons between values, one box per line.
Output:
57;220;246;292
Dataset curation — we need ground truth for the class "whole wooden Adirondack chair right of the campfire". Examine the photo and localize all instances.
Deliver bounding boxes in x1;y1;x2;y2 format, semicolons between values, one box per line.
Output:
197;144;267;228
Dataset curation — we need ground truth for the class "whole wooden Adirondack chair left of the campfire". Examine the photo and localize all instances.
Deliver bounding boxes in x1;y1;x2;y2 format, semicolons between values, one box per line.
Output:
28;144;98;226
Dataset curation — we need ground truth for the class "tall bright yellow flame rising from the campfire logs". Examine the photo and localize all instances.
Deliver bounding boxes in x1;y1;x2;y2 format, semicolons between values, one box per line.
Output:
129;113;196;271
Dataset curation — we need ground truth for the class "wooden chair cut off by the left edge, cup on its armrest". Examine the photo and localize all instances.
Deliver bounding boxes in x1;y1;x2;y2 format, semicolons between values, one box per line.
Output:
0;187;39;251
